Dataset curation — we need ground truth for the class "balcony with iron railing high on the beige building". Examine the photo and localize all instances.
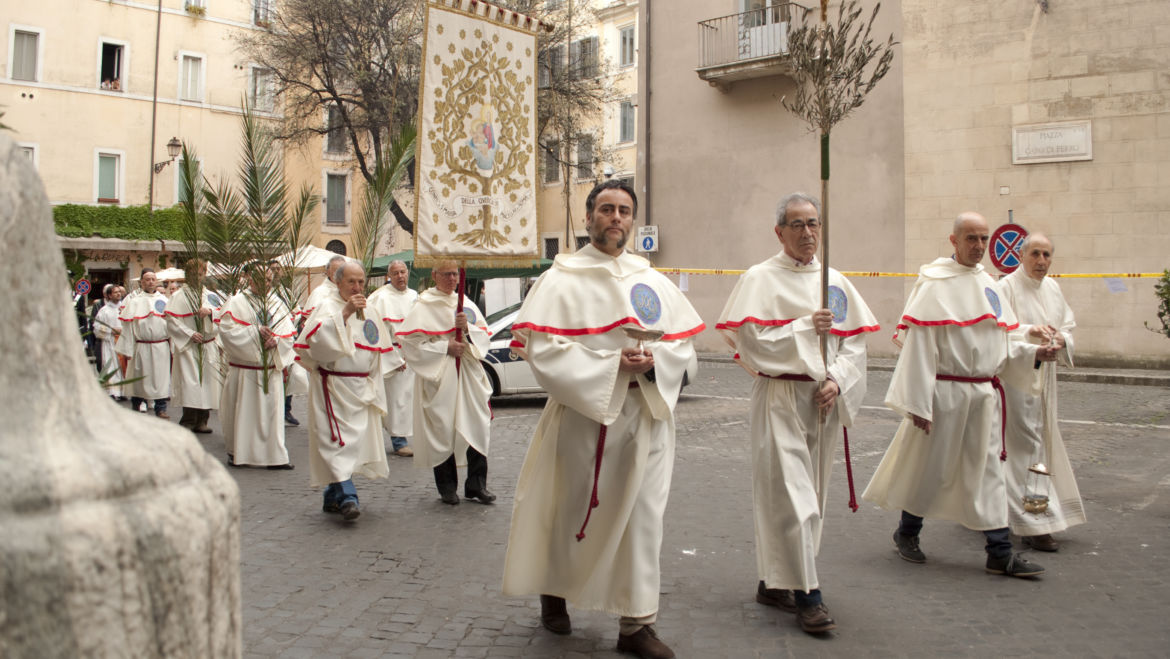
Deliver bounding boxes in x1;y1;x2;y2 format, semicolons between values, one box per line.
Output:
696;2;808;90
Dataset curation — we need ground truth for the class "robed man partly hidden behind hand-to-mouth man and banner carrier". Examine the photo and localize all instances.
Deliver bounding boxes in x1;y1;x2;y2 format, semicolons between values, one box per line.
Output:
369;261;419;458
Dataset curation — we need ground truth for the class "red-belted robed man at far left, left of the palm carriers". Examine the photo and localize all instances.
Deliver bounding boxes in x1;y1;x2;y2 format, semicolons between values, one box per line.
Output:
116;268;171;419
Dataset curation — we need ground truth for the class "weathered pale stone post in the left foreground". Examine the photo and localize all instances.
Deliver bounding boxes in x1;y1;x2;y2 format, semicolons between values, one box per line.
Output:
0;133;241;659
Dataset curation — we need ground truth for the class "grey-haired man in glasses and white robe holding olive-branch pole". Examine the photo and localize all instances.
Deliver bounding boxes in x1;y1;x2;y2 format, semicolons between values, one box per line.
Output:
715;192;880;633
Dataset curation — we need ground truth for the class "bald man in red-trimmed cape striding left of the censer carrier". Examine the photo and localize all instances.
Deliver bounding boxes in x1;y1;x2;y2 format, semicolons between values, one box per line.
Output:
863;212;1057;577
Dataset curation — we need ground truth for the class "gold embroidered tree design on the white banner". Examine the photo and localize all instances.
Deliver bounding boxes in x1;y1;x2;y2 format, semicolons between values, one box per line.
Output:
426;28;534;248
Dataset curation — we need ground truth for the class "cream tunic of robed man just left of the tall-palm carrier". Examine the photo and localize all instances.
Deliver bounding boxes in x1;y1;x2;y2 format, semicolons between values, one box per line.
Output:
166;286;223;410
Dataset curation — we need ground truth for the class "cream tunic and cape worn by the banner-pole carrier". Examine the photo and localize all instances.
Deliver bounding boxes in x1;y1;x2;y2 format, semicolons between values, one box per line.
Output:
398;288;491;468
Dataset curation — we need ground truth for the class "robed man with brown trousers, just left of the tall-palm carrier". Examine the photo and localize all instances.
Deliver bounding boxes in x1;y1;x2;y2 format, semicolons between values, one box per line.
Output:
166;259;223;433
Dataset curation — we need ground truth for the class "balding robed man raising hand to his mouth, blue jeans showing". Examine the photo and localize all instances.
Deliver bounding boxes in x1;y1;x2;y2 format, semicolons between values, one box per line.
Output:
294;263;401;522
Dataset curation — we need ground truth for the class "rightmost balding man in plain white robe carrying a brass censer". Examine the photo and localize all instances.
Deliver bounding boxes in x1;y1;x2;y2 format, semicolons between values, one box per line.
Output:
999;233;1085;551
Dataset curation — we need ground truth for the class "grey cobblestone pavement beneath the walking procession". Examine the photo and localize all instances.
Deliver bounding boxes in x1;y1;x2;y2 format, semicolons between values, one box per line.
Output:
177;363;1170;658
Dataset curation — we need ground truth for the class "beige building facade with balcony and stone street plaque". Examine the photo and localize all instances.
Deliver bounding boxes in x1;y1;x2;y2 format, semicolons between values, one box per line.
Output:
638;0;1170;366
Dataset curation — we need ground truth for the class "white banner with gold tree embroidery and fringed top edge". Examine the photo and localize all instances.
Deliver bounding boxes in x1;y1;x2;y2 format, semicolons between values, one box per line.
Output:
414;0;542;266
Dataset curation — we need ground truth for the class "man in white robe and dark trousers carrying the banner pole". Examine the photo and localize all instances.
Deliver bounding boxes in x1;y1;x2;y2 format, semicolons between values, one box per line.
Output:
397;261;496;506
